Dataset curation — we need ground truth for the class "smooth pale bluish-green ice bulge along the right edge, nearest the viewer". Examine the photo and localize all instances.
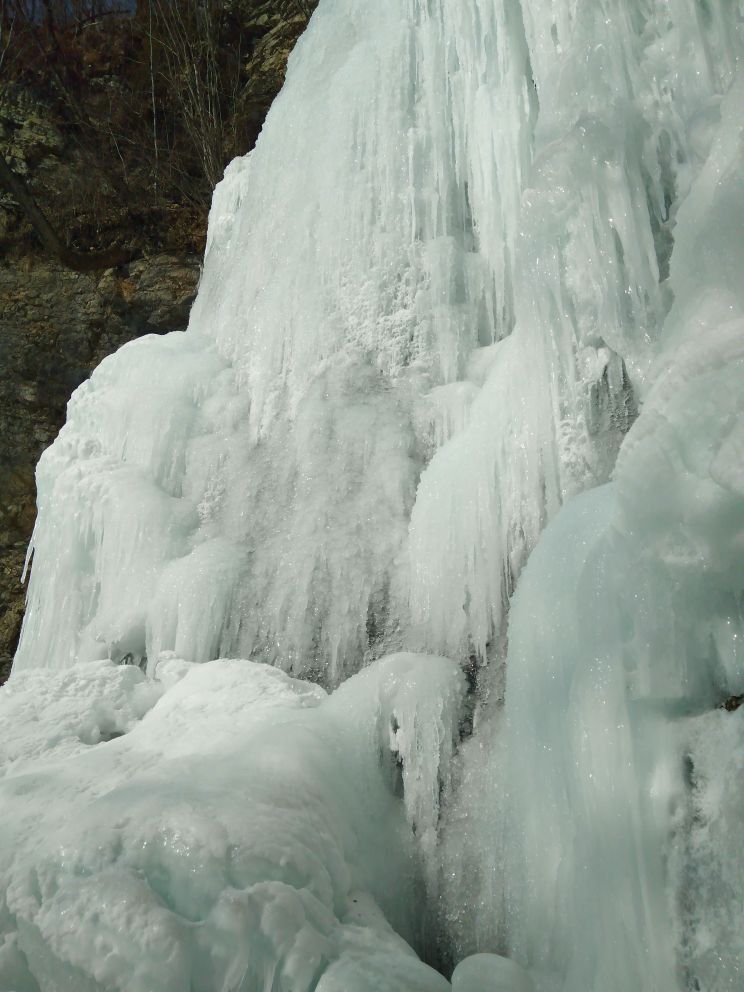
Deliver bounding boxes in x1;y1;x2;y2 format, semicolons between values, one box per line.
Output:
443;70;744;992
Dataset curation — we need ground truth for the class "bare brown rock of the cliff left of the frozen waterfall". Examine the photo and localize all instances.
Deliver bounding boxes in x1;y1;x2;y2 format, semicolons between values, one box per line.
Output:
0;0;315;684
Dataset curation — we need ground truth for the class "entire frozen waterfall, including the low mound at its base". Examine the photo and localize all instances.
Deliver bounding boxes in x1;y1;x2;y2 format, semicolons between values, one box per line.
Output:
0;0;744;992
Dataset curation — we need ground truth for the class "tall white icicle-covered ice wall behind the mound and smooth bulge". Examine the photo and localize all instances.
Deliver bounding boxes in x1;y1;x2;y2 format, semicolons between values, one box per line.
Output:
16;0;741;685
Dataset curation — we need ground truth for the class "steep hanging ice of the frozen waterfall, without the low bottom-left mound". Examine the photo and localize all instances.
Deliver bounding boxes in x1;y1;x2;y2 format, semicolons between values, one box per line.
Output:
15;0;744;992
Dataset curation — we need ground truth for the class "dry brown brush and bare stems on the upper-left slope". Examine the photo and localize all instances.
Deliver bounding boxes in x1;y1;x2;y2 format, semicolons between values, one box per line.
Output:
0;0;315;269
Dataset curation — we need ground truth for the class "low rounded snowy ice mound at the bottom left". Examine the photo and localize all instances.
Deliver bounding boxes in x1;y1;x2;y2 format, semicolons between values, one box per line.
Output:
0;655;463;992
